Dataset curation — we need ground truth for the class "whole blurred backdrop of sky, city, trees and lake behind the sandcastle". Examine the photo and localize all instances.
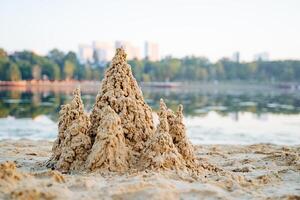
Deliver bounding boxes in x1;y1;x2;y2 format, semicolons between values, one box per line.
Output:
0;0;300;145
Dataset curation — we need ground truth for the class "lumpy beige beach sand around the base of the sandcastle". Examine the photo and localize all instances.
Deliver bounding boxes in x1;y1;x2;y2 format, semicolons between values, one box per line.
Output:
0;139;300;199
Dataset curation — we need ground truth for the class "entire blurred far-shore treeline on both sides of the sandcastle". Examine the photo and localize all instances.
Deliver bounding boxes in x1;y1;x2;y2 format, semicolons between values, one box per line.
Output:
0;49;300;82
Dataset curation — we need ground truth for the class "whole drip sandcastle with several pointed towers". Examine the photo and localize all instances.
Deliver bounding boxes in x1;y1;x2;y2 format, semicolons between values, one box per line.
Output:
48;48;197;172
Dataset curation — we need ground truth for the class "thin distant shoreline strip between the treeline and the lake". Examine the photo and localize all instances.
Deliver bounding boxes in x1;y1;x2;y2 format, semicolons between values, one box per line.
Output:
0;80;300;93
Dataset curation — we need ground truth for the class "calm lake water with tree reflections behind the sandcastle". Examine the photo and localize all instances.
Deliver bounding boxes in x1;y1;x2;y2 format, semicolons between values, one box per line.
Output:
0;86;300;145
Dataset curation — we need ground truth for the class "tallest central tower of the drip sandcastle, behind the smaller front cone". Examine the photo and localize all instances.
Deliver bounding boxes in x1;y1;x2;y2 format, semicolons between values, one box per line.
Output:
89;48;154;155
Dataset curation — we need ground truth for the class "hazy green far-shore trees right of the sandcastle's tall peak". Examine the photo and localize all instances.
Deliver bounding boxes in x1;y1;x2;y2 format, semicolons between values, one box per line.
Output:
129;57;300;82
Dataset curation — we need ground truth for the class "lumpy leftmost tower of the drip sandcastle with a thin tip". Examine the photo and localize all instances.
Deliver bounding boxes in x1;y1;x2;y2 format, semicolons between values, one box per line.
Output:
47;88;91;171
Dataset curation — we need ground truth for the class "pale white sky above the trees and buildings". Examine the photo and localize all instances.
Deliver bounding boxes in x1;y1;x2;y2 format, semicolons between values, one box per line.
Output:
0;0;300;61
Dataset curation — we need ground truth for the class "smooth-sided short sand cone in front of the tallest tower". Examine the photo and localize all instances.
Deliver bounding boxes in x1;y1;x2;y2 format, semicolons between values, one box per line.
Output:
86;106;129;172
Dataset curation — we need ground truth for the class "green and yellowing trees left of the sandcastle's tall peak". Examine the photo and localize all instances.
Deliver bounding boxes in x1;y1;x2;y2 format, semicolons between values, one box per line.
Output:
0;49;104;81
